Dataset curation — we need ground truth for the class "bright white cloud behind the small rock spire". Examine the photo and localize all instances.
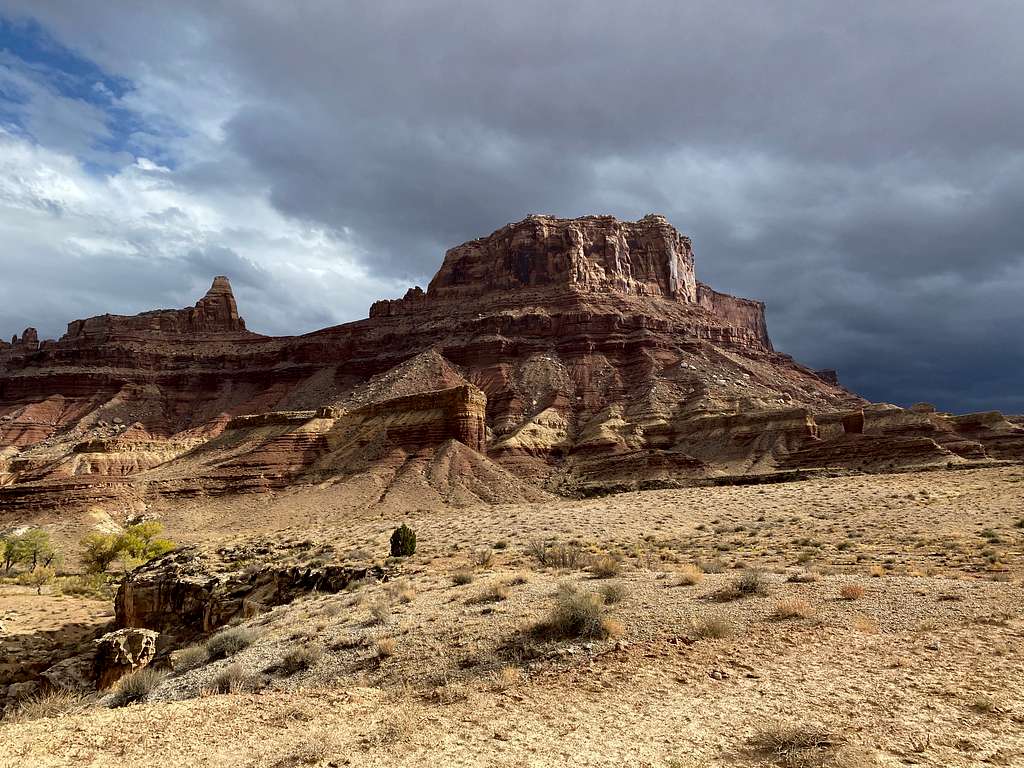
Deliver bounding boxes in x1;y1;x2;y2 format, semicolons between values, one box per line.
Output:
0;130;403;335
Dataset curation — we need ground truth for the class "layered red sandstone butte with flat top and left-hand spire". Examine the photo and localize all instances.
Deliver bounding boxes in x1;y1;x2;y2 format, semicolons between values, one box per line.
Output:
0;215;1024;522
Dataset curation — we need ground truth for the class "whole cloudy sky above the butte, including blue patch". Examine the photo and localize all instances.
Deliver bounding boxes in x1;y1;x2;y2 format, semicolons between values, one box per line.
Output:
0;0;1024;413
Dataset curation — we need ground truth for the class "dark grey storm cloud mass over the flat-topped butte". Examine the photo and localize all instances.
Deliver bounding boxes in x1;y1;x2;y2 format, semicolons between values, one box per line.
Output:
6;0;1024;411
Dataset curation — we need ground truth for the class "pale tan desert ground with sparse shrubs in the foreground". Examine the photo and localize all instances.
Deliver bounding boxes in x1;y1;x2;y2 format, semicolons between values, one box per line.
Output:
0;467;1024;768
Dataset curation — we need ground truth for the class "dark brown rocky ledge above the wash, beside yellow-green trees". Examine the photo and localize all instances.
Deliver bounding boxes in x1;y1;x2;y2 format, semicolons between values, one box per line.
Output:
115;543;390;639
